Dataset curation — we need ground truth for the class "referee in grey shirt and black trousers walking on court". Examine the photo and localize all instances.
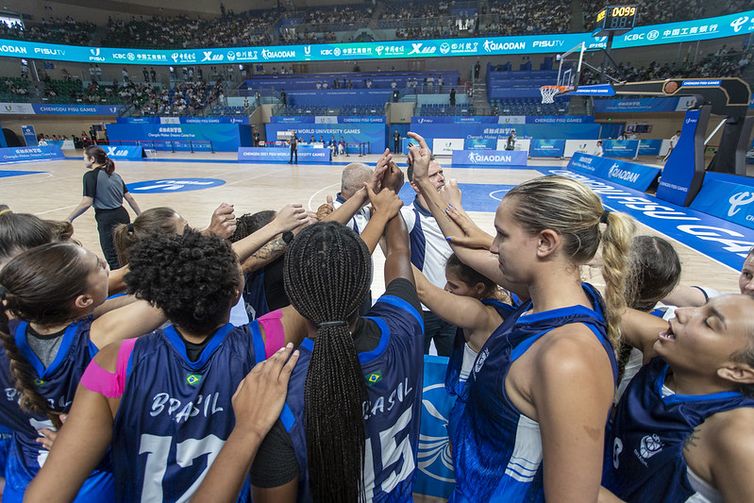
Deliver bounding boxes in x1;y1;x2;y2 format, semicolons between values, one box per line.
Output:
68;145;141;269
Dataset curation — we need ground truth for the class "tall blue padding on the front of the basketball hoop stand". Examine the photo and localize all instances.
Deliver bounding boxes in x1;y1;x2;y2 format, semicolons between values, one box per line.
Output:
657;110;701;206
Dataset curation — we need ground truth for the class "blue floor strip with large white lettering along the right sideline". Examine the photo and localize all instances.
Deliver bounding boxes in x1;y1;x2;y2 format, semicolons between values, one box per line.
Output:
538;166;754;272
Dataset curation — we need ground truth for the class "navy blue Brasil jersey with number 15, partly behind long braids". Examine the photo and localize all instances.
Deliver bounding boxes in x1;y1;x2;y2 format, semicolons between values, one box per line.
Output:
280;295;424;502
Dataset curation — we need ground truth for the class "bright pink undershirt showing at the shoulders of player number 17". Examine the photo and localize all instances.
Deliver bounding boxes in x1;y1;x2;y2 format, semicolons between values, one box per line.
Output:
81;309;285;398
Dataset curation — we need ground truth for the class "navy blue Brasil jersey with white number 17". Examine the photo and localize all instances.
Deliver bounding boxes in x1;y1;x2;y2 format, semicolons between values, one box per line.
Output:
113;322;265;503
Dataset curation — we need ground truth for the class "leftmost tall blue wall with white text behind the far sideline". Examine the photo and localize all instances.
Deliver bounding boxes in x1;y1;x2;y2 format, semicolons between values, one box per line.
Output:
107;124;244;152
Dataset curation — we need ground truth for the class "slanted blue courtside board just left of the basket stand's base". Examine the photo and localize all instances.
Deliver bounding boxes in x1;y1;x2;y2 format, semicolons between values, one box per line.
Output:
568;152;660;192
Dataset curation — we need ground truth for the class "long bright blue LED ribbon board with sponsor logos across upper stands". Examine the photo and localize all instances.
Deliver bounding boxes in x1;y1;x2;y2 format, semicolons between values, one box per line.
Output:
0;11;754;66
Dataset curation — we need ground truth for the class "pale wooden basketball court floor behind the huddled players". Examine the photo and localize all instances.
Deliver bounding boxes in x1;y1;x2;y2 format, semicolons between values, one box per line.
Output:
0;153;738;295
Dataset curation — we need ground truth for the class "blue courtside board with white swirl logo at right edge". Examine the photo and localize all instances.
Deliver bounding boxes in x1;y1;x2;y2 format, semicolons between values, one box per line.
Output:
691;172;754;229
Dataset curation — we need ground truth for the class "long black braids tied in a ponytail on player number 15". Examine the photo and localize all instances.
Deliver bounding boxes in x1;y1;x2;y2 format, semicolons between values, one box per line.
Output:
283;222;372;503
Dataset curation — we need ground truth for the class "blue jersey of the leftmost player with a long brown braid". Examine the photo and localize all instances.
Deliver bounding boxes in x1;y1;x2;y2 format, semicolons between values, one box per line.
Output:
0;317;113;501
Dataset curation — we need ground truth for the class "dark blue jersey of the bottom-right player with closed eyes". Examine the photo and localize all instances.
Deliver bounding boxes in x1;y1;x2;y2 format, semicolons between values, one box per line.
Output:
602;358;754;503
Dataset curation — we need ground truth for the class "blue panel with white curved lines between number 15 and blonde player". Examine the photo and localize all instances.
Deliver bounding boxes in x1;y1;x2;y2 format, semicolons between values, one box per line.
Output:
414;355;455;498
